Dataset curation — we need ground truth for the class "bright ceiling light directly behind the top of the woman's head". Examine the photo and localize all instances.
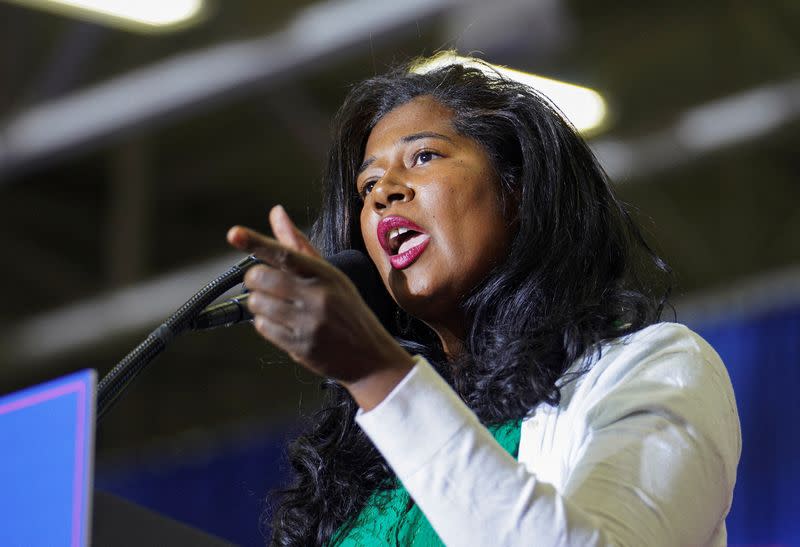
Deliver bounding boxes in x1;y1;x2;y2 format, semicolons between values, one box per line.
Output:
412;53;608;135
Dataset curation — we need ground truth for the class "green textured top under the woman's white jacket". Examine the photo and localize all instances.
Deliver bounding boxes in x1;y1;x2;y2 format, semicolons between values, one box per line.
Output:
328;420;522;547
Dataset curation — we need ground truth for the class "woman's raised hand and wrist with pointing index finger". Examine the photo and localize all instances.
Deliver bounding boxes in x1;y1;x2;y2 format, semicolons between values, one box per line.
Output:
228;206;413;410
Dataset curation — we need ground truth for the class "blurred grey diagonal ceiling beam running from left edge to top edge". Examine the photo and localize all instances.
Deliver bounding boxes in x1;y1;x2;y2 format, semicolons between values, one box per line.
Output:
0;0;460;181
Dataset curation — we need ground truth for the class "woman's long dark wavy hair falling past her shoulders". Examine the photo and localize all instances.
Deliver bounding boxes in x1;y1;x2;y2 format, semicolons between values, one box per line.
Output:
272;54;671;545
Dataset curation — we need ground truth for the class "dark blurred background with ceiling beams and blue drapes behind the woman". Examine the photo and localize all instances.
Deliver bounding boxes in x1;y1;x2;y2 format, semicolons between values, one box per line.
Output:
0;0;800;545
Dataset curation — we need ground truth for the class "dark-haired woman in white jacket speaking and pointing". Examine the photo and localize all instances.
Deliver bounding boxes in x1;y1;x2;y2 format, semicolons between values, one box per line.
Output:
228;56;740;545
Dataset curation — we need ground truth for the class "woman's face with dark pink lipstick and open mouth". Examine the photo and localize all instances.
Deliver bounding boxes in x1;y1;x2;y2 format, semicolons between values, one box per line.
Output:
356;96;510;334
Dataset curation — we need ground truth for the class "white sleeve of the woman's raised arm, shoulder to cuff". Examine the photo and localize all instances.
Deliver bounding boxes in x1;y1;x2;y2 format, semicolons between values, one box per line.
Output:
356;325;741;546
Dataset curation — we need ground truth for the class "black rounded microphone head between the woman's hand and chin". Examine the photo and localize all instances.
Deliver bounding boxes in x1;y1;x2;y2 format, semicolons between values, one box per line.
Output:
328;249;396;332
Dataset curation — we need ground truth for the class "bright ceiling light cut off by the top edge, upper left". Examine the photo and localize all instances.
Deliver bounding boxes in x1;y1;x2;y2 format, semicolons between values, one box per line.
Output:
10;0;203;32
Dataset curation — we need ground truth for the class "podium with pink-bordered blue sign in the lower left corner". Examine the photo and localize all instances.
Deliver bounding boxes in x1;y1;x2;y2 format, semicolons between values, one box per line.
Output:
0;370;232;547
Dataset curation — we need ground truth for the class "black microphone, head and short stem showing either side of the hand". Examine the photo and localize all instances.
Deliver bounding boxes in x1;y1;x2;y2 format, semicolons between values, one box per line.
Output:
192;249;393;330
